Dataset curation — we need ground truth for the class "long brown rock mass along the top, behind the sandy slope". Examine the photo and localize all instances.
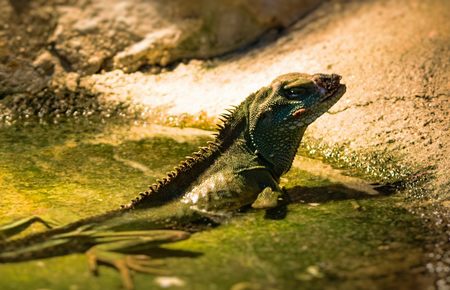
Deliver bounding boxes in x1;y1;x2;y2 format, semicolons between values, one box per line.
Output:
0;0;320;79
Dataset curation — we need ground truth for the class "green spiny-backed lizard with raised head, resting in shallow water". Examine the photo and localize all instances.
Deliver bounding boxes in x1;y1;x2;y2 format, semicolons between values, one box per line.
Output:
0;73;346;289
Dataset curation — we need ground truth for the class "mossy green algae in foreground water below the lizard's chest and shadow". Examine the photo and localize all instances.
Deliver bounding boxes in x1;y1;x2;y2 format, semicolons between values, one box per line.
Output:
164;200;423;289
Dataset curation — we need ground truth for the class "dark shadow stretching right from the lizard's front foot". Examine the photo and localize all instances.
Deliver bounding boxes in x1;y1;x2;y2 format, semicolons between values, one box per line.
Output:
264;184;397;220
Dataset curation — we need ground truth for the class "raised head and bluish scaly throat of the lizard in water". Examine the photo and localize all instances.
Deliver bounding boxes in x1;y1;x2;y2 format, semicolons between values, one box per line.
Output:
248;73;346;176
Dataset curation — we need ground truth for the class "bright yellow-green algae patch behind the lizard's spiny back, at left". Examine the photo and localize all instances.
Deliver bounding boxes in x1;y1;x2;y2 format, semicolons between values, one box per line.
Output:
0;122;204;222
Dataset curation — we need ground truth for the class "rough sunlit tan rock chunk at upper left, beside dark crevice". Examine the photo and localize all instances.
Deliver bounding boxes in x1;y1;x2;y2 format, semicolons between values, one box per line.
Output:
48;2;142;74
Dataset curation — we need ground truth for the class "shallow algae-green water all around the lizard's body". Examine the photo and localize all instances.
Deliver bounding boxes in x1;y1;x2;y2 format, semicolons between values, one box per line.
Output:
0;121;431;290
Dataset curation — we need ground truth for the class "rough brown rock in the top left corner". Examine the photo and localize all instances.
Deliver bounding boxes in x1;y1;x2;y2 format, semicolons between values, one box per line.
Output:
0;0;55;99
